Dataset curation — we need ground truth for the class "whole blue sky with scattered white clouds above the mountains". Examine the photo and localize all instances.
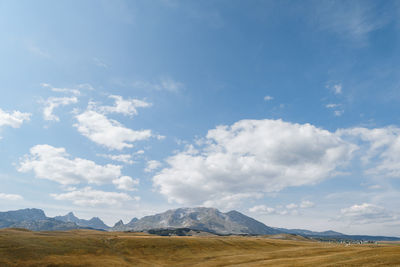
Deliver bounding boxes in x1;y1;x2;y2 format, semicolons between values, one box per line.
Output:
0;0;400;236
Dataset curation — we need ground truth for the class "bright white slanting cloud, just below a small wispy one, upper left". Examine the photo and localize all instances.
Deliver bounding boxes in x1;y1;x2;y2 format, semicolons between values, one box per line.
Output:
74;110;152;150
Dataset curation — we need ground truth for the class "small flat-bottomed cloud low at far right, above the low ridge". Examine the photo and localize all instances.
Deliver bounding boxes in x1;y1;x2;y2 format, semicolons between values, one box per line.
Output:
340;203;398;224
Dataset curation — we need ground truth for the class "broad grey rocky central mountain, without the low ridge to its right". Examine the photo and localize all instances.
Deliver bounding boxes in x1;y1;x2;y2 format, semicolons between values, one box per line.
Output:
111;207;281;235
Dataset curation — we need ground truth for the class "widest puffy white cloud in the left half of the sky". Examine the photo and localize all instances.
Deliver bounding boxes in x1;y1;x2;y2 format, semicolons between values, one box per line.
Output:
18;145;131;185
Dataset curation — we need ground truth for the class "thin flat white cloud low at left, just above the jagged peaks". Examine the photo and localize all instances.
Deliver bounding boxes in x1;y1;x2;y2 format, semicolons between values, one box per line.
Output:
51;187;132;207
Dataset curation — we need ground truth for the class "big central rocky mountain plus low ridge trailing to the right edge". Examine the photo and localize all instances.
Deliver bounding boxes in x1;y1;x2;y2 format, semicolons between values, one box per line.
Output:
110;207;400;241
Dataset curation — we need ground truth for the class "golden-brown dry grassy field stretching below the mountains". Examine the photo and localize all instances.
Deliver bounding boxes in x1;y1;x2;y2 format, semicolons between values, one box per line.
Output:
0;229;400;266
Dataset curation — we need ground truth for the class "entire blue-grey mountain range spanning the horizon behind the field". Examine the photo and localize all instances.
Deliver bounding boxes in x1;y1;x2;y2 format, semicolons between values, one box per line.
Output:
0;207;400;241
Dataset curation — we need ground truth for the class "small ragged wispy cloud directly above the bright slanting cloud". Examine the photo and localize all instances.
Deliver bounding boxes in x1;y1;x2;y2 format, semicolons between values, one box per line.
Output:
99;95;151;116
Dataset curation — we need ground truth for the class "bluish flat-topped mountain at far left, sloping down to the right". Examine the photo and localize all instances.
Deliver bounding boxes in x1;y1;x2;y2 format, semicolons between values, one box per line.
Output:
0;209;80;231
